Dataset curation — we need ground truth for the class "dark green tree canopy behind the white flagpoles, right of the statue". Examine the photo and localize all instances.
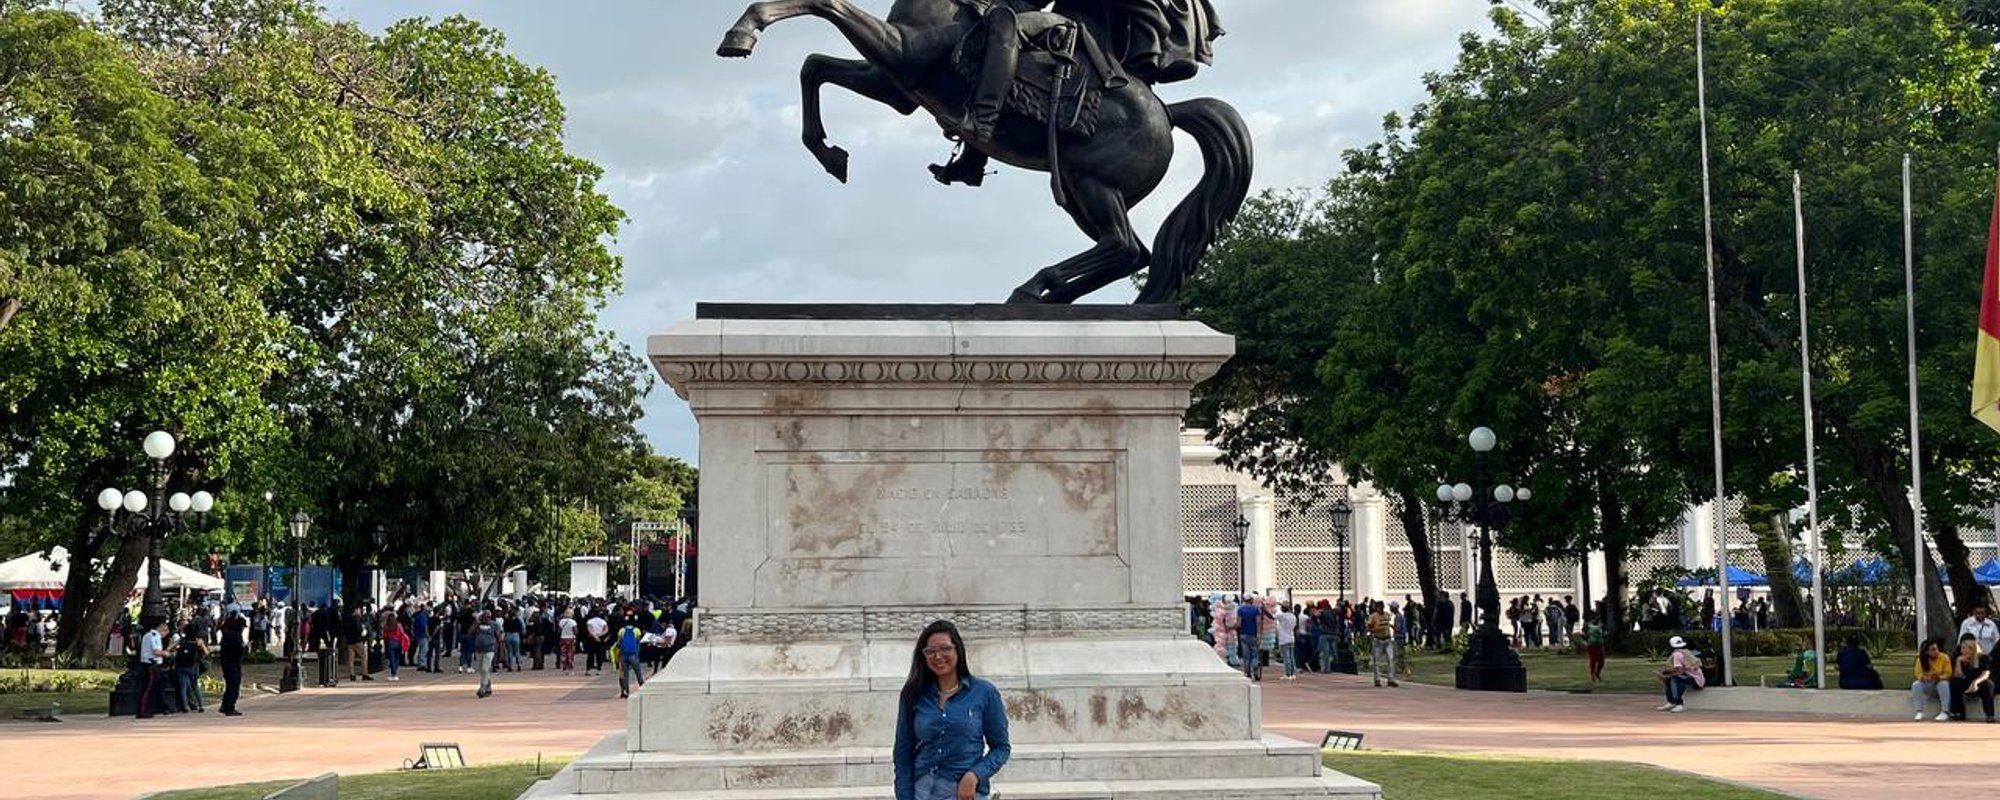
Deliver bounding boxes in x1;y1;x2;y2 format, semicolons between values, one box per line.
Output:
1190;0;2000;636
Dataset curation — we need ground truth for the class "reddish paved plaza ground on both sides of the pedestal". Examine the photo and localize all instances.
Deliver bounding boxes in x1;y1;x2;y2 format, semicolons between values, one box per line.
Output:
11;656;2000;800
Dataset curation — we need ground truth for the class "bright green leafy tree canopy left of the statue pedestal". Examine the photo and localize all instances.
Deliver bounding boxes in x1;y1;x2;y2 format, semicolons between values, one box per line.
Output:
0;0;678;652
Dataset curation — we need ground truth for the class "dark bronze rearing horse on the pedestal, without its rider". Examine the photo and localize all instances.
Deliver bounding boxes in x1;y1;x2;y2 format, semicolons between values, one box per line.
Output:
716;0;1252;304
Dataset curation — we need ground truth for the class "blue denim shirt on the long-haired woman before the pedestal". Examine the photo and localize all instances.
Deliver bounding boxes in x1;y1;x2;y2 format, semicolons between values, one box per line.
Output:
896;678;1012;800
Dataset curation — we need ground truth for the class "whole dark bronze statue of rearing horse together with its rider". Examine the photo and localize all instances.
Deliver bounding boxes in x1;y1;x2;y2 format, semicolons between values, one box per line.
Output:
716;0;1252;304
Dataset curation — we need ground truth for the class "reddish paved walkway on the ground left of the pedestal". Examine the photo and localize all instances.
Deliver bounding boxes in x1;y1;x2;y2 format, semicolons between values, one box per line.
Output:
13;654;624;800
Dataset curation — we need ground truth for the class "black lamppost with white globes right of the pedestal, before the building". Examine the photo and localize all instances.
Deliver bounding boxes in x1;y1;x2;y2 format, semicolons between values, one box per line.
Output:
1438;426;1534;692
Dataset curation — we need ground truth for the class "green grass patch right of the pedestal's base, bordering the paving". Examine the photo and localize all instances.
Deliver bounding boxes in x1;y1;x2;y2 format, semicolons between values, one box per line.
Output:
1326;750;1784;800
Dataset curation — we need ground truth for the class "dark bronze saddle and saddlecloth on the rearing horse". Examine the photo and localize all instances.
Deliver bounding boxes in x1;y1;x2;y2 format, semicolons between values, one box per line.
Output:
952;12;1128;136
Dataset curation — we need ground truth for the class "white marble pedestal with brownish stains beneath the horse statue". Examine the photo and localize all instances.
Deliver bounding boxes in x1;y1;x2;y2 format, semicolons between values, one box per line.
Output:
528;318;1378;800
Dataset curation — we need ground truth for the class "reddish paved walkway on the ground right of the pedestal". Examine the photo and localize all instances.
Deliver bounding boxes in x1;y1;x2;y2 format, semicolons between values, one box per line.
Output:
1264;672;2000;800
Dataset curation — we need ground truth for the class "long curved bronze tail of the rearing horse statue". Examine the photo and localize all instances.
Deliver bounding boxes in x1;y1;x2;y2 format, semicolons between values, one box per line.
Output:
1138;98;1252;302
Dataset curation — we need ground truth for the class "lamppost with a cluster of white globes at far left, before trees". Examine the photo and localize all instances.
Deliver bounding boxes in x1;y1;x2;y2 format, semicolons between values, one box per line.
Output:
98;430;216;716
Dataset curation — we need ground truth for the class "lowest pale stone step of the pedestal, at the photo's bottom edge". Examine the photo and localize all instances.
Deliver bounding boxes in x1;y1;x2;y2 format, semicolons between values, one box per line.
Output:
522;772;1382;800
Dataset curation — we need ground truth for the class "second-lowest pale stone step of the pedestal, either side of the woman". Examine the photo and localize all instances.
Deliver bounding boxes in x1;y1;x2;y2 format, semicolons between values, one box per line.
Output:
566;736;1320;796
